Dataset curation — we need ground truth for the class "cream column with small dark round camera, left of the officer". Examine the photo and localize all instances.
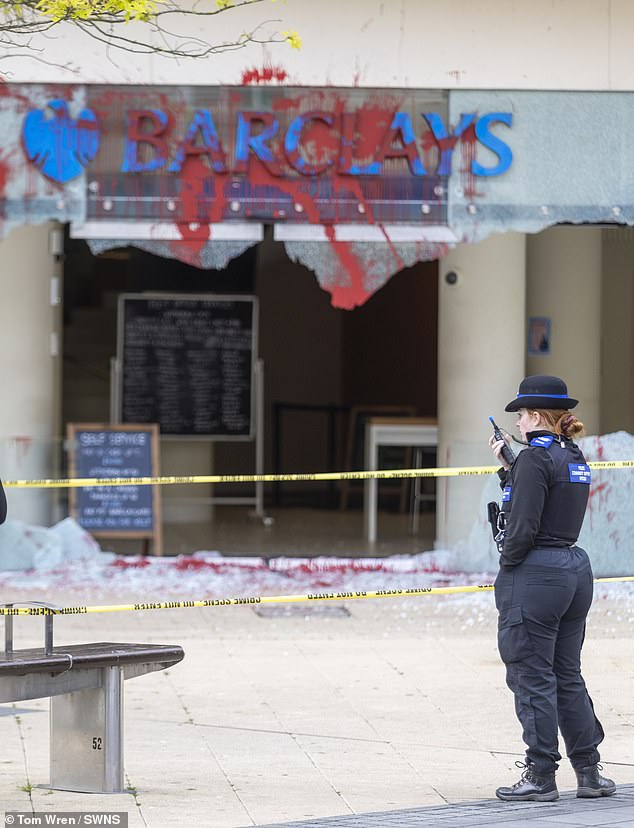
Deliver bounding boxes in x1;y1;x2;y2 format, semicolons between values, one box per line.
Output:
436;233;526;547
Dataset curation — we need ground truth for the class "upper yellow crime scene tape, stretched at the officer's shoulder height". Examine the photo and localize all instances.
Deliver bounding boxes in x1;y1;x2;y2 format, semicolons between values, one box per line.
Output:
3;460;634;489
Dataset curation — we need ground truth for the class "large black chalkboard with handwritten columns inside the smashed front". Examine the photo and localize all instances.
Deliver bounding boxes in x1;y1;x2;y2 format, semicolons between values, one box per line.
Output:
117;293;257;440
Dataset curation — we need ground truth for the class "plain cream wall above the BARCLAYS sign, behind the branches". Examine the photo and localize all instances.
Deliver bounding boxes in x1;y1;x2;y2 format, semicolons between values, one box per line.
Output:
3;0;634;90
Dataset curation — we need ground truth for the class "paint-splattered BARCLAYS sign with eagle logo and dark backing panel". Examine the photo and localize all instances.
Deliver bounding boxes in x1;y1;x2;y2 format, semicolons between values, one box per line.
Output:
16;86;513;227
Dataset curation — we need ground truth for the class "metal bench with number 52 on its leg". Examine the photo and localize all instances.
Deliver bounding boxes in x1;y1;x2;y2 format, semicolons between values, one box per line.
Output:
0;602;184;793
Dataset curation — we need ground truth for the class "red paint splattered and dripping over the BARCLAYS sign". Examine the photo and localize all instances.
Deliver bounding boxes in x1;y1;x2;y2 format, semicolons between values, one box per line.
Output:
81;87;456;308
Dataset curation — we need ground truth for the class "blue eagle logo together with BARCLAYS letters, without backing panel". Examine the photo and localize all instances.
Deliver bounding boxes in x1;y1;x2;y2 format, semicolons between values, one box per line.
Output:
22;95;513;184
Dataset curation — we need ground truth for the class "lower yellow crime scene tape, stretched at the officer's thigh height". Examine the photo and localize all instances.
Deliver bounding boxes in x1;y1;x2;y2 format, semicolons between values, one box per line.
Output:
0;575;634;616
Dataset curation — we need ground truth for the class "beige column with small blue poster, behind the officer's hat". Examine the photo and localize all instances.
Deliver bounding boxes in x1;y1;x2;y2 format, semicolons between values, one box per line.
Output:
526;227;602;434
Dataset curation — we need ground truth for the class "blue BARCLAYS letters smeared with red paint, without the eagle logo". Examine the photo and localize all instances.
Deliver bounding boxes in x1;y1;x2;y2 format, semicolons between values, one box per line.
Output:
121;109;513;178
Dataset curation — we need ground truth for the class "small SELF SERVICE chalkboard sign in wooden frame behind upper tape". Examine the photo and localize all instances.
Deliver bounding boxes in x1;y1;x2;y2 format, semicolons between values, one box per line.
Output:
68;423;162;555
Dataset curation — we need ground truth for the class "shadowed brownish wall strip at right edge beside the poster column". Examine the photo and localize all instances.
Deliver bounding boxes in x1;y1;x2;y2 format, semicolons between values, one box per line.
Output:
601;229;634;434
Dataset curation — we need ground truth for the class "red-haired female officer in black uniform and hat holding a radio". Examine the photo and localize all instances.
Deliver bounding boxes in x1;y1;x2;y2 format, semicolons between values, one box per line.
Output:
489;376;616;802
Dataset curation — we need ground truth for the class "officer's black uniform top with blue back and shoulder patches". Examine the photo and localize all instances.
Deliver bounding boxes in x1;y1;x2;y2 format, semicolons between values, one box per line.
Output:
498;431;590;569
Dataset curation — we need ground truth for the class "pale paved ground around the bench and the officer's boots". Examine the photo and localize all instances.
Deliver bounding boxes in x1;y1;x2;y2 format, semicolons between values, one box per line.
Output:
0;585;634;828
